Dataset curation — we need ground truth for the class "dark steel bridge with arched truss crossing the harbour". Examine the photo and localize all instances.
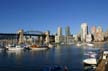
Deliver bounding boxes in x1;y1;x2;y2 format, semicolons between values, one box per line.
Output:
0;30;54;42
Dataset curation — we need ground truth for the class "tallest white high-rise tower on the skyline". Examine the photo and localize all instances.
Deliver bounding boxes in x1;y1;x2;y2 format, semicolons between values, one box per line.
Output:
81;23;88;41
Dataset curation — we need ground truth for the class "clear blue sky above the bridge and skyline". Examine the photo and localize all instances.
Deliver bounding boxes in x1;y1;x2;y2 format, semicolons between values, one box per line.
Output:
0;0;108;34
